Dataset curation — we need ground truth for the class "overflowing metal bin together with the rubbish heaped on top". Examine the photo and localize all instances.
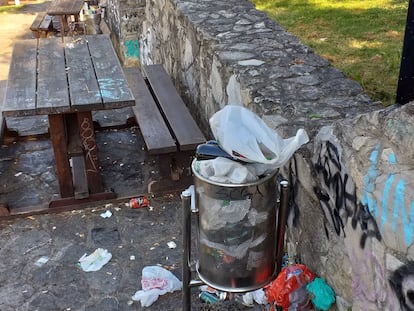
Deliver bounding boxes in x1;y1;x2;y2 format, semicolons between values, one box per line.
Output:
183;105;309;310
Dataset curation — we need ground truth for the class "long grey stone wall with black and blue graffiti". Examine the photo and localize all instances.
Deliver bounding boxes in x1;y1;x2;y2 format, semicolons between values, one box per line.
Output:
111;0;414;310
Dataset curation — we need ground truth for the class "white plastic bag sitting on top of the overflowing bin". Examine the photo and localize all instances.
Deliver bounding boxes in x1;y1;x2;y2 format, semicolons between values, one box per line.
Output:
210;105;309;168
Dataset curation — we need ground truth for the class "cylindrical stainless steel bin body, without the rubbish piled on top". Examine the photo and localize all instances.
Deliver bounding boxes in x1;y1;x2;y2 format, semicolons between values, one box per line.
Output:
192;161;278;292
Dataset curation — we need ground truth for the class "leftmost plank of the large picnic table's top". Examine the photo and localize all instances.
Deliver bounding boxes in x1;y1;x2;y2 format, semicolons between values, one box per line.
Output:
3;40;37;117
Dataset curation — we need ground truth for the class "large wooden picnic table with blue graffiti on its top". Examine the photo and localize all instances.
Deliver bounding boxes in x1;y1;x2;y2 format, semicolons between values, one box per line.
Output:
2;35;135;208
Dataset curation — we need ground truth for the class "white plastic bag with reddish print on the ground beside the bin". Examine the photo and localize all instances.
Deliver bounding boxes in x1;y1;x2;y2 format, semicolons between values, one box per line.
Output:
132;266;183;307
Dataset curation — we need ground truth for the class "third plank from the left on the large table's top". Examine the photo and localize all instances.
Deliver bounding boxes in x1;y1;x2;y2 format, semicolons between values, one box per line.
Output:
65;38;104;110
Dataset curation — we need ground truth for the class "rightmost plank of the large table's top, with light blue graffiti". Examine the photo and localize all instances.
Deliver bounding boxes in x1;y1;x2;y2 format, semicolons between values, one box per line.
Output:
86;35;135;108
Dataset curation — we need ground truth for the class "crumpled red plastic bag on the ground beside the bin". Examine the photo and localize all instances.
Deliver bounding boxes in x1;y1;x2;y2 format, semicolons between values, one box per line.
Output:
264;264;315;311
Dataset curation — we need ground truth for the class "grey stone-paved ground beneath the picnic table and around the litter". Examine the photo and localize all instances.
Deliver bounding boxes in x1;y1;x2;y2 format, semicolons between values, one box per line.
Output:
0;3;263;311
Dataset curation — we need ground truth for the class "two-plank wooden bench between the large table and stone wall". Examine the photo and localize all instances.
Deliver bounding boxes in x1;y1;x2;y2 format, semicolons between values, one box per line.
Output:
124;64;206;193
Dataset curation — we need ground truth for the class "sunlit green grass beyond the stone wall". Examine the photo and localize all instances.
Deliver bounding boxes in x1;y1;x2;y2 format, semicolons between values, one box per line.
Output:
251;0;408;106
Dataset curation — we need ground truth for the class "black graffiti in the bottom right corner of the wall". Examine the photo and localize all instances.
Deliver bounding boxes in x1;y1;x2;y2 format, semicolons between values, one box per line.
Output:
389;261;414;311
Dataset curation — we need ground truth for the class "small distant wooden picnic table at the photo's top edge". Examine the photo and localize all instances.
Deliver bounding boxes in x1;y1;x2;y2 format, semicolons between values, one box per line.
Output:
47;0;85;37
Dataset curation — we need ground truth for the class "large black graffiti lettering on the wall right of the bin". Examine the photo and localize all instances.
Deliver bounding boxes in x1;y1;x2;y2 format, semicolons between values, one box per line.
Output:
314;141;381;248
